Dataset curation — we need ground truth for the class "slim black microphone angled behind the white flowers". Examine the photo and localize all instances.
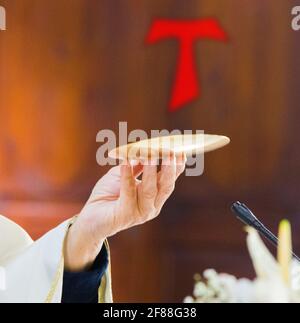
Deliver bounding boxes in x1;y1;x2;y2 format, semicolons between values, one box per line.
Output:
231;202;300;262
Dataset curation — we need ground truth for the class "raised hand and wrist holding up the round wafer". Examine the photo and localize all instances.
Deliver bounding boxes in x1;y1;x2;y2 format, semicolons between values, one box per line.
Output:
65;154;186;271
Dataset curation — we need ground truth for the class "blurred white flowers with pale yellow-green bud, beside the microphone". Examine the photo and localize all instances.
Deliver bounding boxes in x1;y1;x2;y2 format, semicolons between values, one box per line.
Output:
184;220;300;303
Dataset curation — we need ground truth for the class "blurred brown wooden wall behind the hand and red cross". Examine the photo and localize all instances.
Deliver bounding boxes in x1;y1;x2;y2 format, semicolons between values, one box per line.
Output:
0;0;300;302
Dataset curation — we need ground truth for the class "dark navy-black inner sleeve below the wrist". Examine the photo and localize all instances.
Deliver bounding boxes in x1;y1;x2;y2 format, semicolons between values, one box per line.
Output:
62;245;108;303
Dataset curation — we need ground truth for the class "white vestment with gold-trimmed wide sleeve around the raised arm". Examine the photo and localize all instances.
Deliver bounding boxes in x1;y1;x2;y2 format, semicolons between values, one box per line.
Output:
0;215;112;303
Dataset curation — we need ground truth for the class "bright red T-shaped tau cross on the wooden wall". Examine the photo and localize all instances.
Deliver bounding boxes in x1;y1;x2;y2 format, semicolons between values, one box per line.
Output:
147;18;228;111
